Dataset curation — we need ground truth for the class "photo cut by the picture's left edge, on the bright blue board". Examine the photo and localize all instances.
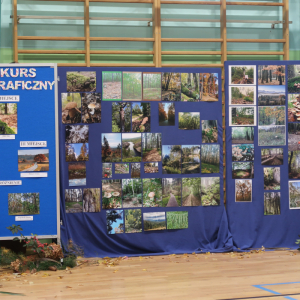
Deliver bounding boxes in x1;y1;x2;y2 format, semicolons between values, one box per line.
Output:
0;103;18;135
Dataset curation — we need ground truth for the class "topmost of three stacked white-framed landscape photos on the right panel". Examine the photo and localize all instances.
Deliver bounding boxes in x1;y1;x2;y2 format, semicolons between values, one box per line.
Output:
229;65;256;85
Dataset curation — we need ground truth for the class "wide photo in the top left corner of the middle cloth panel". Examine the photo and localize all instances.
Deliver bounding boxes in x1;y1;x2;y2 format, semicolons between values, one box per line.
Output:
67;71;96;92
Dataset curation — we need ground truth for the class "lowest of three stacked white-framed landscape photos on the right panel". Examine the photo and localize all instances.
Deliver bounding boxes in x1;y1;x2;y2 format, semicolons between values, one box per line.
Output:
229;106;256;126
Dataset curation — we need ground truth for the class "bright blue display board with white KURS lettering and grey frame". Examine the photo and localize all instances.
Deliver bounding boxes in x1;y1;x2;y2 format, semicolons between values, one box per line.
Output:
0;64;60;240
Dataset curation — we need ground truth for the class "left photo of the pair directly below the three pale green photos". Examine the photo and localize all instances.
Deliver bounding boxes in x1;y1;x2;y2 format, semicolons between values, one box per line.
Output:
111;102;131;132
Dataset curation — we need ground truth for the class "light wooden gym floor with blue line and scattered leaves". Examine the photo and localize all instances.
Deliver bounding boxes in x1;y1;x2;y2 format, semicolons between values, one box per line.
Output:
0;251;300;300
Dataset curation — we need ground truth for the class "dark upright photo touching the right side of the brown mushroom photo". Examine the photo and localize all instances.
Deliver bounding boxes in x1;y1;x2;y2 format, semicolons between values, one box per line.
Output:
81;93;101;123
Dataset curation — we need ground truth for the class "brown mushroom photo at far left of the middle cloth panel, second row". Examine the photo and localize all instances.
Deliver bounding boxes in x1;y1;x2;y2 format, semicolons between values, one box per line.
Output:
61;93;81;124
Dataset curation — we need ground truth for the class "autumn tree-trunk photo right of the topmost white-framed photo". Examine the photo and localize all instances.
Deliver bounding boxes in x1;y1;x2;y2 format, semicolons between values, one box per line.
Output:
258;65;285;85
